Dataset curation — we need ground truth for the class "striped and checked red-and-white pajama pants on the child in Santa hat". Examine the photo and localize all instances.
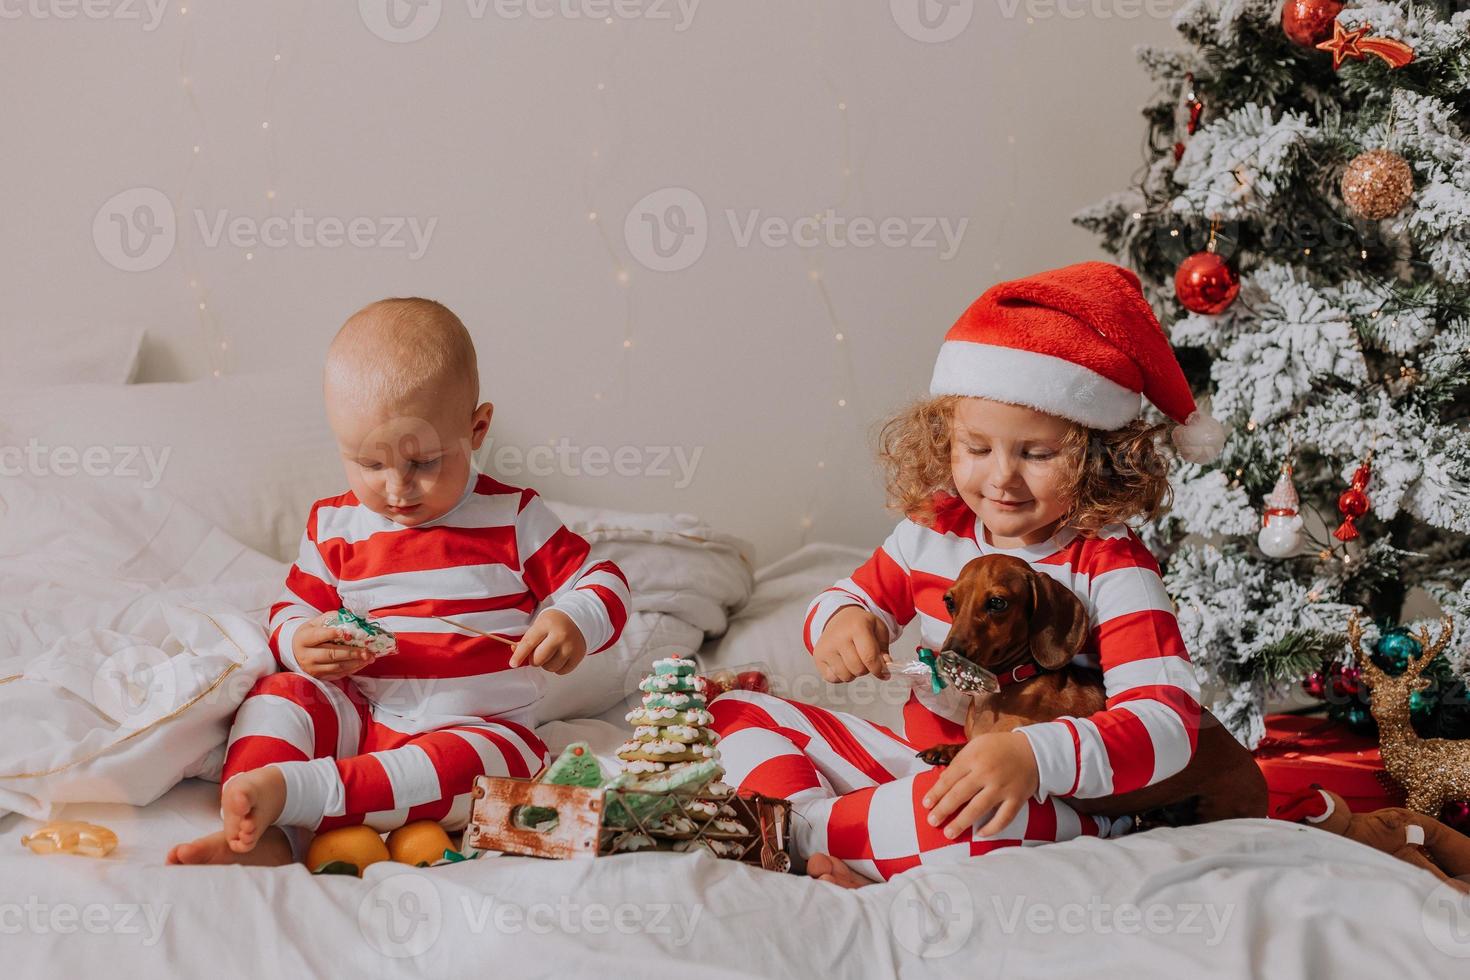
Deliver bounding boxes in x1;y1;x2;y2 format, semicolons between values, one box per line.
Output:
710;691;1122;880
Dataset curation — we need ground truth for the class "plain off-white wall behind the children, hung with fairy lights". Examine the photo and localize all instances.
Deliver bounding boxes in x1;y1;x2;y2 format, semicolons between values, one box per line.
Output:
0;0;1170;561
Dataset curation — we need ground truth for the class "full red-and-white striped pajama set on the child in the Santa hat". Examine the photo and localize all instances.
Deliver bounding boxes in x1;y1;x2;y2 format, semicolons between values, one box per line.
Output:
711;497;1200;877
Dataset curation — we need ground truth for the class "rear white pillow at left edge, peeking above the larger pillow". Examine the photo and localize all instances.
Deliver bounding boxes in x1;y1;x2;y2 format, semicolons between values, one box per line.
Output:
0;323;144;388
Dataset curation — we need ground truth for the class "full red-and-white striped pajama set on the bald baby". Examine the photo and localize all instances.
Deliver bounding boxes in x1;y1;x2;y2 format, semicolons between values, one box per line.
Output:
222;470;631;830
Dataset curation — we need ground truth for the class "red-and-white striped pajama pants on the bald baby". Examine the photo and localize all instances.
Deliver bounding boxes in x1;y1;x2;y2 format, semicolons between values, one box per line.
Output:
221;673;547;846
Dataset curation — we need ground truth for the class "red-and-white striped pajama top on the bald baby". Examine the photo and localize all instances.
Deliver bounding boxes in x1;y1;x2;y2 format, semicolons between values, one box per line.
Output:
269;469;631;728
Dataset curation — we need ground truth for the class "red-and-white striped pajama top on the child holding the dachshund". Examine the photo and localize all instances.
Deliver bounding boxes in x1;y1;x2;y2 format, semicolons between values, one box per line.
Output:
804;495;1200;799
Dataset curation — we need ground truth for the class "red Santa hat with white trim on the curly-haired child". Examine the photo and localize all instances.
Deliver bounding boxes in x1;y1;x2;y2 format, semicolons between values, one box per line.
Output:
929;262;1225;463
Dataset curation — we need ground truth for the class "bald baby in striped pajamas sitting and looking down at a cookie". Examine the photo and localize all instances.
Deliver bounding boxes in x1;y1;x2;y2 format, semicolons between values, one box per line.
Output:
168;298;629;864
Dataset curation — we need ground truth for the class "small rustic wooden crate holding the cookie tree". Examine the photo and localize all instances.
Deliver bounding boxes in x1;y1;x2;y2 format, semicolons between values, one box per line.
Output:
465;776;791;871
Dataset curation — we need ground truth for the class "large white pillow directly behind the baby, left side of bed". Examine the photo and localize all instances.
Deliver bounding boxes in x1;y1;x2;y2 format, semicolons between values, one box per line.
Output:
0;370;345;560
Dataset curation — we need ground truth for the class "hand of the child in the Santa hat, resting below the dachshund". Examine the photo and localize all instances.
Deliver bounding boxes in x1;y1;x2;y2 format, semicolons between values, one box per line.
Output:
923;732;1041;840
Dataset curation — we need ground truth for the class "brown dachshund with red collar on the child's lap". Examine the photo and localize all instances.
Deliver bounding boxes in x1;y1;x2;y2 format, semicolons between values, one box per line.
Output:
919;555;1267;827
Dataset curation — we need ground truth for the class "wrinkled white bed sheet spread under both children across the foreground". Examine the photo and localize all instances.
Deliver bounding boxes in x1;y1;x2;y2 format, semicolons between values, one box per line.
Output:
0;547;1470;979
